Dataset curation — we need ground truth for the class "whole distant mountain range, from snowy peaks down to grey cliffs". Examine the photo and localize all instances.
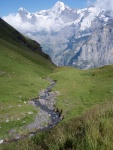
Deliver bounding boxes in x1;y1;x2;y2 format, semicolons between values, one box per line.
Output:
4;1;113;69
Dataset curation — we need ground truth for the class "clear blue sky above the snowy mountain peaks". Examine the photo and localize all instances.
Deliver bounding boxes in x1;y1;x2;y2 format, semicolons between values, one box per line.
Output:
0;0;94;17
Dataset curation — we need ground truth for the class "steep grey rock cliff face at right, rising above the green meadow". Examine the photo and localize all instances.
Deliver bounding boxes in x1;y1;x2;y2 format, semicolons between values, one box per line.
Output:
68;23;113;69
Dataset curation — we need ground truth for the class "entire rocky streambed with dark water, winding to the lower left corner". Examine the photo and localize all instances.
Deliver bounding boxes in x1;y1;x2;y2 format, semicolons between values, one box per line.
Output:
0;79;63;144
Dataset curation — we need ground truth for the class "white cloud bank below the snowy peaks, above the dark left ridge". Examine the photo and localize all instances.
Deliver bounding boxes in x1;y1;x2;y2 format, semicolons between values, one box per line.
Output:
3;13;63;33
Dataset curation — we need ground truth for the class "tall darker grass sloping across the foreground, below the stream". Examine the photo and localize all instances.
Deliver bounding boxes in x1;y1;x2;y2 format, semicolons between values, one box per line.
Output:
0;101;113;150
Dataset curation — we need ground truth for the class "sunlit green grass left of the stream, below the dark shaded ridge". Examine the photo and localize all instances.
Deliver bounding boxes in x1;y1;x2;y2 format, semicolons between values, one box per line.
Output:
0;44;52;138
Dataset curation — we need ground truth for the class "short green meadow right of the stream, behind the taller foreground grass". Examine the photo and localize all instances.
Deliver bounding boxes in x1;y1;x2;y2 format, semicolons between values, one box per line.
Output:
50;65;113;121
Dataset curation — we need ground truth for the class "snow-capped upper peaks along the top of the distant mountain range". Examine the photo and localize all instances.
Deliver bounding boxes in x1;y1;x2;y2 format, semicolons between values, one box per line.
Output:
4;1;109;32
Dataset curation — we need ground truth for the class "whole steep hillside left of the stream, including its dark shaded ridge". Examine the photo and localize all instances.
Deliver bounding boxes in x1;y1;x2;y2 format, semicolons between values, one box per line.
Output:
0;19;55;139
